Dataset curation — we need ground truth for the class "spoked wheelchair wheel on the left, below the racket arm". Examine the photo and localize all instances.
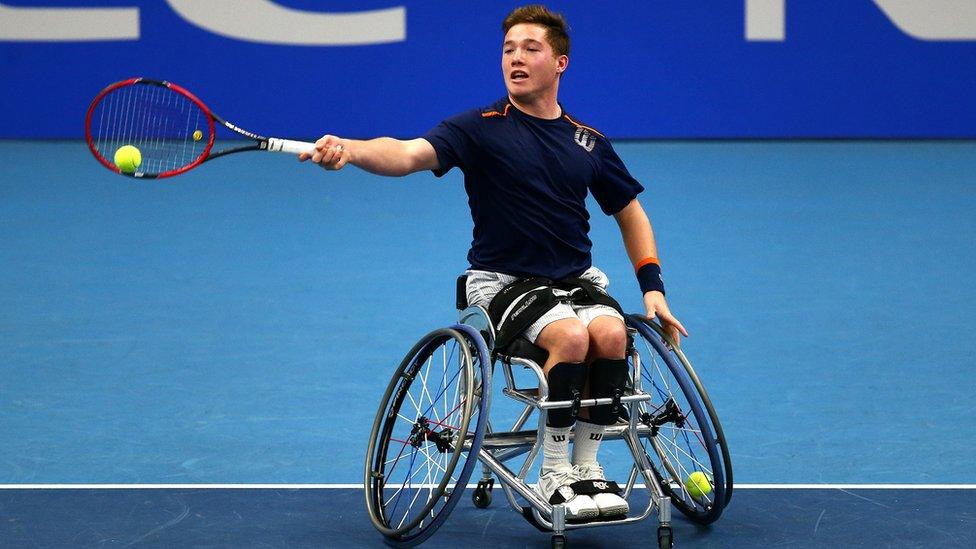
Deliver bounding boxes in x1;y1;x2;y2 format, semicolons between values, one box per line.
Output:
365;327;487;545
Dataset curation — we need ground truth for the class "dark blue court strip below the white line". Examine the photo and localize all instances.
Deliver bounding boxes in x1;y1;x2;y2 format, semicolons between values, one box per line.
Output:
0;488;976;548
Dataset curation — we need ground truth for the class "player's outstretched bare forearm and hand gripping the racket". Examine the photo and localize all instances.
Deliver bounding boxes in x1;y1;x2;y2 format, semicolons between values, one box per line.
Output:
298;135;439;176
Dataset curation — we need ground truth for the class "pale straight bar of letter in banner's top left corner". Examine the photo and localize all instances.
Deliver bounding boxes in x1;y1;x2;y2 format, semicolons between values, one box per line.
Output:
0;4;139;42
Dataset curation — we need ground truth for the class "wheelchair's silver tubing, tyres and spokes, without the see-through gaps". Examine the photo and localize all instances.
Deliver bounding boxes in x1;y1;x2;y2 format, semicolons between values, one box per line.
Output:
365;306;732;548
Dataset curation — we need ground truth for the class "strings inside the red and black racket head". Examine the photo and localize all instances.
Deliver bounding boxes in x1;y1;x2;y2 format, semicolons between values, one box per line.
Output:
92;83;211;174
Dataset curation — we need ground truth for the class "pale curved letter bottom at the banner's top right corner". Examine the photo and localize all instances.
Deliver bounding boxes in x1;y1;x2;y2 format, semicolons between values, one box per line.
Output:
874;0;976;41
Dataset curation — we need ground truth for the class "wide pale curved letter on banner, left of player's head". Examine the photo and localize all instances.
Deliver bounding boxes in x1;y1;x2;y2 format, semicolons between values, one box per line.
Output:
166;0;407;46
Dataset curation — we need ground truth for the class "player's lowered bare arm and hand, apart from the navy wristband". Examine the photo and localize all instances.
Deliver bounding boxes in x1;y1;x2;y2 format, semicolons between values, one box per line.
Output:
613;198;688;344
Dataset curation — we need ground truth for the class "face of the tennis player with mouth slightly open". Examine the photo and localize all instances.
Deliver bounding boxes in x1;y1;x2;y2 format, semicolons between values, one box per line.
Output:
502;23;569;101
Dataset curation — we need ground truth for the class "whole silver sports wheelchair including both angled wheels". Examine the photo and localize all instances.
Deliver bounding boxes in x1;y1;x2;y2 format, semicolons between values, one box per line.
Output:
364;277;732;548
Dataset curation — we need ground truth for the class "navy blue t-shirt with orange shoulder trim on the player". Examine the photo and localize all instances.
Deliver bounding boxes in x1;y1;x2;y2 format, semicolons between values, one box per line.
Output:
424;98;644;278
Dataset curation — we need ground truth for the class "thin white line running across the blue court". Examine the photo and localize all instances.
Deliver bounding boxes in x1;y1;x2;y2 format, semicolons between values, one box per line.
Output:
0;484;976;490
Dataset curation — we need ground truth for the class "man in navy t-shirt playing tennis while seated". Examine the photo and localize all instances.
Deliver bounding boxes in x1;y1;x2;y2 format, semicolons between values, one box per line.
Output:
299;5;688;519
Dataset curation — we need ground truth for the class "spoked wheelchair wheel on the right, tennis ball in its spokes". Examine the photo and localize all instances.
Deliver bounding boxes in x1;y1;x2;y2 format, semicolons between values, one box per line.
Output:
627;314;732;524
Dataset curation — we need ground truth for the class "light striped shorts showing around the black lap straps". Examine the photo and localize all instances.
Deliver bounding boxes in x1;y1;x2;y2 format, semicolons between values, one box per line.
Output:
465;267;624;343
